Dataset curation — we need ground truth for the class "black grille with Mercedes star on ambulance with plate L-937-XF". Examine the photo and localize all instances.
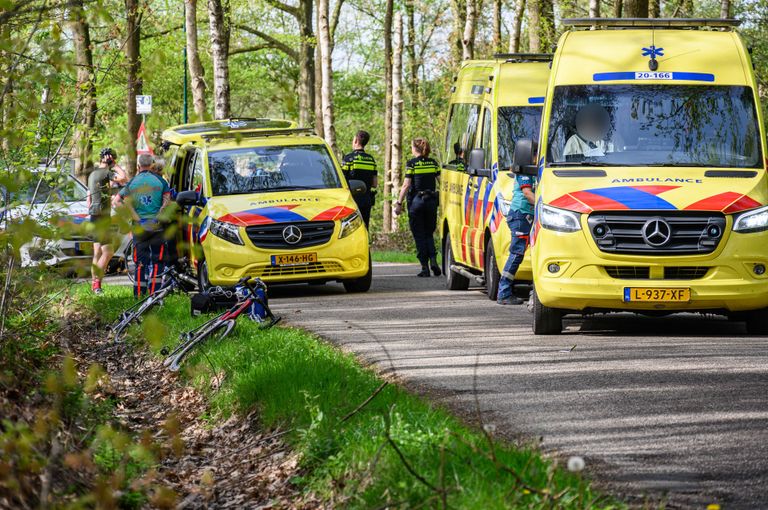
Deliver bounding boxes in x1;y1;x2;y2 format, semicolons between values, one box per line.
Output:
588;211;725;256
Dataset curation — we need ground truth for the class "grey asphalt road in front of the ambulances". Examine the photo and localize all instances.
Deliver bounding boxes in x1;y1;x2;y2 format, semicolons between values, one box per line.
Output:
270;264;768;509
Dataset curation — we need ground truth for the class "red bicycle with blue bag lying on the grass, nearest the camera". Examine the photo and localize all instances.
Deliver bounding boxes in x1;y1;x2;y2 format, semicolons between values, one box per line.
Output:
160;276;280;372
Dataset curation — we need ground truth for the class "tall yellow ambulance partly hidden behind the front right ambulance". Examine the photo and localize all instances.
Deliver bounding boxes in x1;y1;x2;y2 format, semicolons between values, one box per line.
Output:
438;54;552;300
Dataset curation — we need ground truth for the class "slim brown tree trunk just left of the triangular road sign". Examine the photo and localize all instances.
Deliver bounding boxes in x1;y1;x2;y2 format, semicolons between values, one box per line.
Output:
125;0;141;176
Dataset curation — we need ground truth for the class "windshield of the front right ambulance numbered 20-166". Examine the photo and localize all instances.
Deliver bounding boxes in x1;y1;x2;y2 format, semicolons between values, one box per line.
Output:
547;85;762;168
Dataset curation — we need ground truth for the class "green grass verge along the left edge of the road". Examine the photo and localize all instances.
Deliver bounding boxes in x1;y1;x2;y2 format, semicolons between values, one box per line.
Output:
79;287;623;508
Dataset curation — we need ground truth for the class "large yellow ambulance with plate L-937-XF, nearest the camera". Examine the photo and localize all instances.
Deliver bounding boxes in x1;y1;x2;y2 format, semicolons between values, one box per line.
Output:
515;19;768;334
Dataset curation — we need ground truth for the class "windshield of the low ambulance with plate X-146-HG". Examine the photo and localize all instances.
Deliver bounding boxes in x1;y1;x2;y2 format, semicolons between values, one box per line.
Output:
208;145;341;195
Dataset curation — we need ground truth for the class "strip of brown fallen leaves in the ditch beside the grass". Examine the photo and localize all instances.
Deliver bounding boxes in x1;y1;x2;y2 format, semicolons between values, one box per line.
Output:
62;304;320;509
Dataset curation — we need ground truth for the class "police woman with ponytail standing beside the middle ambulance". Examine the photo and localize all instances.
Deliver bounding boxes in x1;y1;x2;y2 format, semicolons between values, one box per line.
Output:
395;138;441;277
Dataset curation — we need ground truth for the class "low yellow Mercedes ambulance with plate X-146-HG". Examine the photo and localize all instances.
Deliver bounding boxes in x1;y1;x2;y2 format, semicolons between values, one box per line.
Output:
163;119;371;292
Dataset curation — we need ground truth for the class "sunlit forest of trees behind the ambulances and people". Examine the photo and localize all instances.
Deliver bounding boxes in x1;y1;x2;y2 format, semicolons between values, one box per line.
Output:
0;0;768;232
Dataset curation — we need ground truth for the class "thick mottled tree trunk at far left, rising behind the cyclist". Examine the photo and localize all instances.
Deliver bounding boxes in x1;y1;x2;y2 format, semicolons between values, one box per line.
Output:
70;0;96;181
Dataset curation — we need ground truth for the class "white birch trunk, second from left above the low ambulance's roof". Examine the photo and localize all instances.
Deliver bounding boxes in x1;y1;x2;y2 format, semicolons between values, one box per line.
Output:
208;0;231;119
